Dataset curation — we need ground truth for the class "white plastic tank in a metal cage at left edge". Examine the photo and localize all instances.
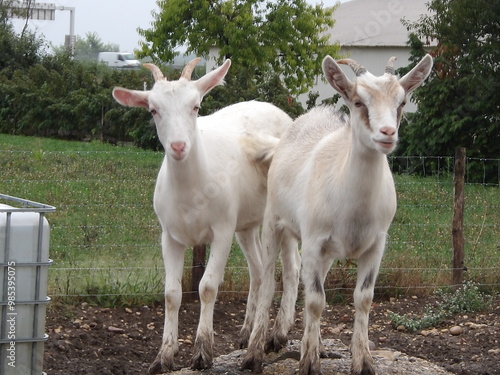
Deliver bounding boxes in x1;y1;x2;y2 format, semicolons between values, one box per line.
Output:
0;194;55;375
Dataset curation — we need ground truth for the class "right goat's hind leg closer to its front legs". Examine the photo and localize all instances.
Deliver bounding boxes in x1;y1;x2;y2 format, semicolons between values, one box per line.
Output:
265;231;301;353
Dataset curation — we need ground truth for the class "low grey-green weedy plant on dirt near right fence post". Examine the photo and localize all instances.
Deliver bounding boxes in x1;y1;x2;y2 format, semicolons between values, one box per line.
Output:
389;281;492;332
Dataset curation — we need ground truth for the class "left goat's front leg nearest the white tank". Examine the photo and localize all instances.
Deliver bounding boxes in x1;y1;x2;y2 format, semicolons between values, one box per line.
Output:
149;231;185;374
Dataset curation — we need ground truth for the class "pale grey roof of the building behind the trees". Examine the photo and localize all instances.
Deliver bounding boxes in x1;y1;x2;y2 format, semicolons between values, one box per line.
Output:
330;0;430;47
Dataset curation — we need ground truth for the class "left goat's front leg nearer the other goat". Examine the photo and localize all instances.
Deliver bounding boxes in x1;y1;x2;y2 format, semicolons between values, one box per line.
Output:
191;228;234;370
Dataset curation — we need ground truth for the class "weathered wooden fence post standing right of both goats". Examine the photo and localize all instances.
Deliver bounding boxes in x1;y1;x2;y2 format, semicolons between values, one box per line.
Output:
452;147;466;288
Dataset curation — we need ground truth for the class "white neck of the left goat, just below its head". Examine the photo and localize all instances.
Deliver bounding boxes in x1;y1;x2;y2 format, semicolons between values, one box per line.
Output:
165;130;209;188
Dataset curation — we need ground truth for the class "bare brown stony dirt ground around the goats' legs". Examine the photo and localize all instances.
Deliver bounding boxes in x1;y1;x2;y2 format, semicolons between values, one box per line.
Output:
44;297;500;375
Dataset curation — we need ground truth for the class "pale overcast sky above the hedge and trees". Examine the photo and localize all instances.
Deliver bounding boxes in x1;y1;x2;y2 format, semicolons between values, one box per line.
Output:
14;0;345;52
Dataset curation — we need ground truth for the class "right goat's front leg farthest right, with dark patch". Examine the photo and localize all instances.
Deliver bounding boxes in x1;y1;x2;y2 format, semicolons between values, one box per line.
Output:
351;239;385;375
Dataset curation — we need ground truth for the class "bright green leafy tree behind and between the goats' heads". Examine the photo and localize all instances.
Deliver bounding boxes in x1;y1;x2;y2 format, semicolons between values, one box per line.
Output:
138;0;339;95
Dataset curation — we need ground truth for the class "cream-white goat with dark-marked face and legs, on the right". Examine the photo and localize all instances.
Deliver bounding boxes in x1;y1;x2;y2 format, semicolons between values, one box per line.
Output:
242;55;432;375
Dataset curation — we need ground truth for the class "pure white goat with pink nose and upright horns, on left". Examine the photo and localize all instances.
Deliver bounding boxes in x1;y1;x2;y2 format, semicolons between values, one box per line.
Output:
113;59;297;374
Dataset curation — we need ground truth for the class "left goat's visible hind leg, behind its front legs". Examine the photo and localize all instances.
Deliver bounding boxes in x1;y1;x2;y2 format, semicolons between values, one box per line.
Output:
236;227;262;349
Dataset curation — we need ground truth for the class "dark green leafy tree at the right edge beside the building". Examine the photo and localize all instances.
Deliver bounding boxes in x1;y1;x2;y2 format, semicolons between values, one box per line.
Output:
399;0;500;169
